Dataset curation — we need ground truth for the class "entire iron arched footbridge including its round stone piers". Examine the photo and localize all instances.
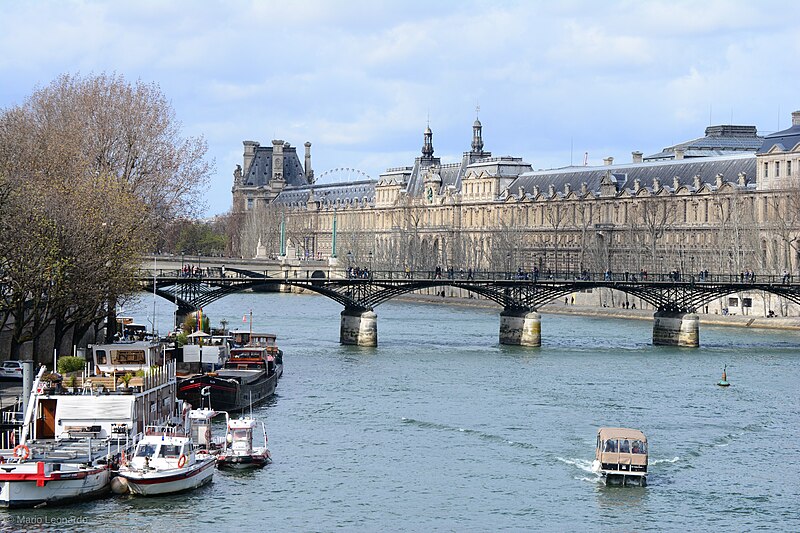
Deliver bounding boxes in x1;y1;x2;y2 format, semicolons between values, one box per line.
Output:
139;262;800;347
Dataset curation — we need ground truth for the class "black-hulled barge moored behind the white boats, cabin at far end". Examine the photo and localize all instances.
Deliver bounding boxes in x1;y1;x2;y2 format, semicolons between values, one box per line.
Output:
178;333;283;412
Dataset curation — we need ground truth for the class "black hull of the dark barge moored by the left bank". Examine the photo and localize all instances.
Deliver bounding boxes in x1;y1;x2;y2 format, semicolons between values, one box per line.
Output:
178;371;280;412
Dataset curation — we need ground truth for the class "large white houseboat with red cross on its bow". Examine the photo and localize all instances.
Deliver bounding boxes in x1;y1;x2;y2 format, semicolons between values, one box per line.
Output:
0;363;176;507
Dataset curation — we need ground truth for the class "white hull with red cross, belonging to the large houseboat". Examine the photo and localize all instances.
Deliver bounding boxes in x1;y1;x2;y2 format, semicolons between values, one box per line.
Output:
0;462;111;508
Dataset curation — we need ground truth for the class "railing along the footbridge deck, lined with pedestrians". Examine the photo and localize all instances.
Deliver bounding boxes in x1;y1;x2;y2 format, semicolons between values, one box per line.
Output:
139;267;800;285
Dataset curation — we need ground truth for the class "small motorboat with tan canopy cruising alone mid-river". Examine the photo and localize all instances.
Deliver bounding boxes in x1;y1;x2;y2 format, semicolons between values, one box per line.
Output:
592;428;647;487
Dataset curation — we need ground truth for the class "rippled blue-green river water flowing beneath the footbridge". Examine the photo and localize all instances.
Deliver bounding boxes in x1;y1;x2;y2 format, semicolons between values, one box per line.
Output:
0;293;800;532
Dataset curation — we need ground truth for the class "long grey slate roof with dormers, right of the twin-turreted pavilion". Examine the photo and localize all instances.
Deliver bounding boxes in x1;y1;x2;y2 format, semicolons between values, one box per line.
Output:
509;153;756;196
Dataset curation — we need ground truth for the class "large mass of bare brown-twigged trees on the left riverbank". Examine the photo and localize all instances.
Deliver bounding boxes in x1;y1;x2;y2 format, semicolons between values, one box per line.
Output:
0;75;211;355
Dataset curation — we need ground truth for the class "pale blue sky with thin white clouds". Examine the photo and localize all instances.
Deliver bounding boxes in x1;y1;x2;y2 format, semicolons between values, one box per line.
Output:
0;0;800;216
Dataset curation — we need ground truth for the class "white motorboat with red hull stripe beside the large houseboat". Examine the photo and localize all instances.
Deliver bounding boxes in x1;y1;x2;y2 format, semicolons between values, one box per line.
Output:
113;412;216;496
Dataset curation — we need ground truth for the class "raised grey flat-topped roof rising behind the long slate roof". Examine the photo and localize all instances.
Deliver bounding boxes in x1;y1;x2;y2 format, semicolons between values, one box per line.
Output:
644;124;764;161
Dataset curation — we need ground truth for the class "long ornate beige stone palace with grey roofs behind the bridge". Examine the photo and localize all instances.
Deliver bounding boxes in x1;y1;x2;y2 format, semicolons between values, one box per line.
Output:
233;112;800;312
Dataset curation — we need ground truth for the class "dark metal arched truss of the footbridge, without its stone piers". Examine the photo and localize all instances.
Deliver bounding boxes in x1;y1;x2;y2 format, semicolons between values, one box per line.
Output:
140;270;800;313
